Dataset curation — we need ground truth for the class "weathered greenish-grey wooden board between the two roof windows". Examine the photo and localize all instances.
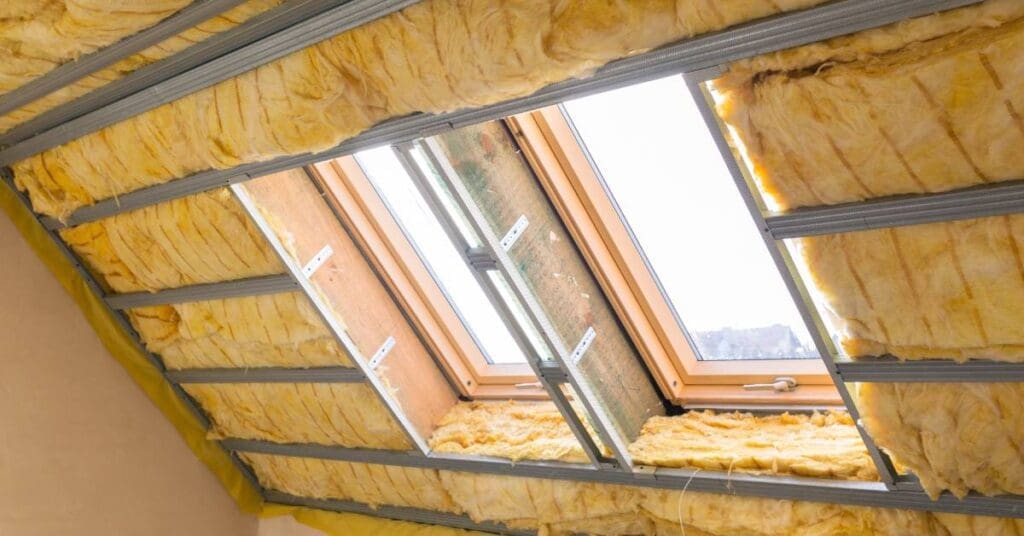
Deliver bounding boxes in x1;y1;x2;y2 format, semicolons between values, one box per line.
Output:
436;122;665;441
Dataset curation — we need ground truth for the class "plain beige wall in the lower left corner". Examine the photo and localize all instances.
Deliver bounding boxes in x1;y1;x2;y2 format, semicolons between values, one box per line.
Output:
0;215;260;536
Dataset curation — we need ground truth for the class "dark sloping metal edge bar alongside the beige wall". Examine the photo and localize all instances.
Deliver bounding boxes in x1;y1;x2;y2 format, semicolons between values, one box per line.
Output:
0;171;261;496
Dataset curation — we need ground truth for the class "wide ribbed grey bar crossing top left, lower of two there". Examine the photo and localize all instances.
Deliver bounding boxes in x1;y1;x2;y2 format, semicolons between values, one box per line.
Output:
0;0;417;165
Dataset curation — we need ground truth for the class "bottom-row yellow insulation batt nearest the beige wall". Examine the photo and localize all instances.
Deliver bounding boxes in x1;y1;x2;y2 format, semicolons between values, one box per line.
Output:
242;453;462;512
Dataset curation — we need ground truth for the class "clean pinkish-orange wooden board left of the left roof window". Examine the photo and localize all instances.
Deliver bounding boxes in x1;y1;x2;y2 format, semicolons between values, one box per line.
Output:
239;170;458;438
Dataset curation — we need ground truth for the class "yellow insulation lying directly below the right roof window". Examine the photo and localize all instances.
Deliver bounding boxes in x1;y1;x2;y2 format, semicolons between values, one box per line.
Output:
630;411;879;481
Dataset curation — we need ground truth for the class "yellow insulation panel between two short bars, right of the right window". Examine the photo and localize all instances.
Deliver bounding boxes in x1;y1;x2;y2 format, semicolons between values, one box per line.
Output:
797;215;1024;362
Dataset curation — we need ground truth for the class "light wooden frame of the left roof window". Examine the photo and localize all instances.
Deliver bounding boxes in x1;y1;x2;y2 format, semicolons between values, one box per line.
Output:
307;156;547;399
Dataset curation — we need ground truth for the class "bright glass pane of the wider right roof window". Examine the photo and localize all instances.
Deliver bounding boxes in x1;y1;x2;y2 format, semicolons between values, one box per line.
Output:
565;76;817;360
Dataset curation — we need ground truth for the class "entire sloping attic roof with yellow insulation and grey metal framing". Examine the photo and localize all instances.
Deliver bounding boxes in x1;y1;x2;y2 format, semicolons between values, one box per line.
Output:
0;0;1024;535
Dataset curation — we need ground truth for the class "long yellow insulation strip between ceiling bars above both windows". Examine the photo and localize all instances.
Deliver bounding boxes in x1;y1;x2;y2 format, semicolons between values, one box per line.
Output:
14;0;822;217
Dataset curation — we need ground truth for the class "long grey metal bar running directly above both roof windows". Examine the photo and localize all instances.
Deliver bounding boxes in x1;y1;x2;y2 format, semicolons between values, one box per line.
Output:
39;0;980;224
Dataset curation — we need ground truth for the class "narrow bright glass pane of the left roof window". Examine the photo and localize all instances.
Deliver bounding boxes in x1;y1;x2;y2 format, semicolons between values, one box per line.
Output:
356;147;526;364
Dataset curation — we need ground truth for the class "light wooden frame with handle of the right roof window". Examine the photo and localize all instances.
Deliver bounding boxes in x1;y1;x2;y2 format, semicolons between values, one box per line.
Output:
506;107;842;406
